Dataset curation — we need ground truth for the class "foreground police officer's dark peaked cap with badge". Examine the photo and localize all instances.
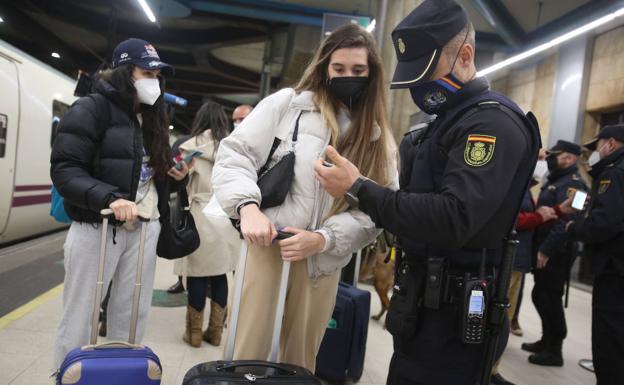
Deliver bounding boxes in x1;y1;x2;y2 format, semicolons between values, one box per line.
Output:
390;0;468;89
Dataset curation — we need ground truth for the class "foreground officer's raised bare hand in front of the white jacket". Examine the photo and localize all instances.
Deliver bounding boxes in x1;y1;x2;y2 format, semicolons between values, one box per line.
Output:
314;146;362;198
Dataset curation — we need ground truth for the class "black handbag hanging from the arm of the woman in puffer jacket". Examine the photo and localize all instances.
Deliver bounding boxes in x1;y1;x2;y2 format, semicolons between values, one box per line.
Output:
156;189;199;259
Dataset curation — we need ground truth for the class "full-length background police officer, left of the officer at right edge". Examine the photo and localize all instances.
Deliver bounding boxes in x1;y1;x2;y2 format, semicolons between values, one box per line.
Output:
522;140;587;366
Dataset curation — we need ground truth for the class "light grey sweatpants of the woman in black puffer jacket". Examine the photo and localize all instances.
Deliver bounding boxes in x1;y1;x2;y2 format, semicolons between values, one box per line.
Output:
54;220;160;368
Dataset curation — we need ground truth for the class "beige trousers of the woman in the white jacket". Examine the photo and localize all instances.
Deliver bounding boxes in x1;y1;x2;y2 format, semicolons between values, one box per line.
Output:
228;245;340;372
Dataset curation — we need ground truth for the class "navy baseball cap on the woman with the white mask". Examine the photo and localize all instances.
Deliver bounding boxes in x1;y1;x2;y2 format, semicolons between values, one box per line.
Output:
113;38;174;76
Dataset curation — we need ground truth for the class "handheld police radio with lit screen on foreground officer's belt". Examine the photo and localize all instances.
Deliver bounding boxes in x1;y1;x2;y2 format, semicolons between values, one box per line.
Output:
461;276;489;344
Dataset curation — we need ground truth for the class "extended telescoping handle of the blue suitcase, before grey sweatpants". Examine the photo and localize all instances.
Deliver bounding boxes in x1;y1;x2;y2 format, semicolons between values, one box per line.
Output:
89;209;149;345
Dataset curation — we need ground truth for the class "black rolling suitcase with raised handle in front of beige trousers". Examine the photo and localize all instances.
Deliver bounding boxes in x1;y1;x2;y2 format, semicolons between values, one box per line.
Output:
182;242;322;385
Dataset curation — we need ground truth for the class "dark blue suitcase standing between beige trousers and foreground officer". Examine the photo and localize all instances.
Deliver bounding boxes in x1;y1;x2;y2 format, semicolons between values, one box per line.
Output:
315;282;371;382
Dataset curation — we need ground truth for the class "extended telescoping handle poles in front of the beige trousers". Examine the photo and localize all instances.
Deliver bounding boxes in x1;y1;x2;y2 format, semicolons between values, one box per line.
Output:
225;241;290;362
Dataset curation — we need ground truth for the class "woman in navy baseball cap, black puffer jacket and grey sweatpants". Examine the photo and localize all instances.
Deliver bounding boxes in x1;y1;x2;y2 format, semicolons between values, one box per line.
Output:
50;39;188;367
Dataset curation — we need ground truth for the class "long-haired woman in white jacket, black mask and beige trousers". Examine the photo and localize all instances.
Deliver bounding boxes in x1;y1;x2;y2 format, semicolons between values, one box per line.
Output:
212;25;397;371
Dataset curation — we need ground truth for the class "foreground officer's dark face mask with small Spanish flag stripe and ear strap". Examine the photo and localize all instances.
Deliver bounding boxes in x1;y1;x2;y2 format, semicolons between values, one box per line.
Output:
410;33;468;115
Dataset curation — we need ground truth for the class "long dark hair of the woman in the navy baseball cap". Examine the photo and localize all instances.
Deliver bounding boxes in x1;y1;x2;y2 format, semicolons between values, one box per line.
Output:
98;65;171;179
